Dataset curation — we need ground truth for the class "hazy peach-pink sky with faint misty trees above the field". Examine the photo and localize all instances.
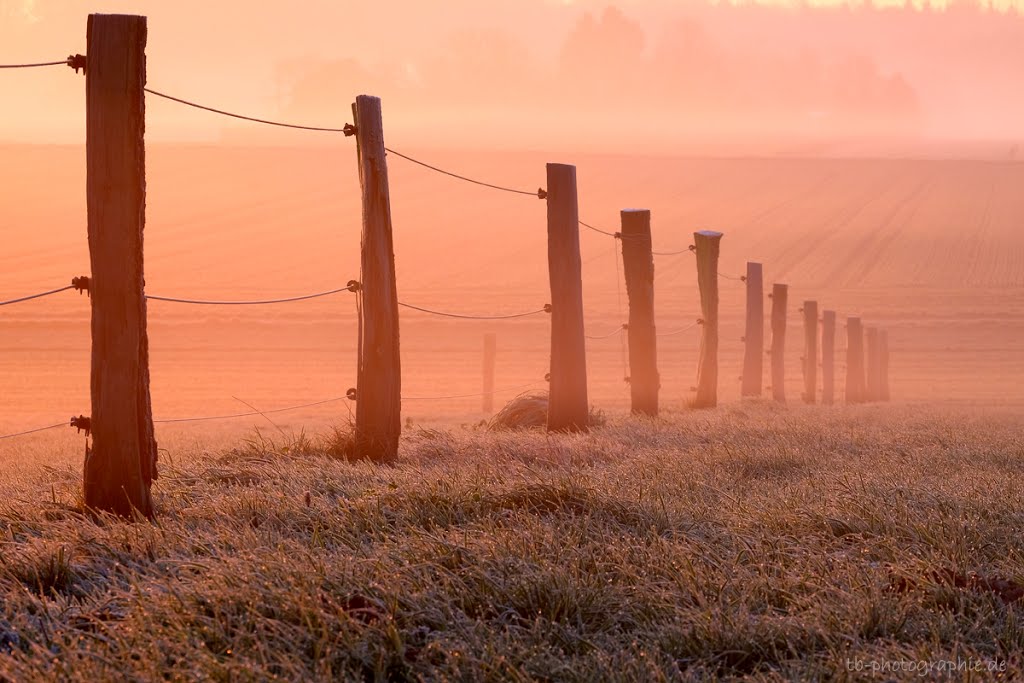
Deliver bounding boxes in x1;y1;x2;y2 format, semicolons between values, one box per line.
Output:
0;0;1024;150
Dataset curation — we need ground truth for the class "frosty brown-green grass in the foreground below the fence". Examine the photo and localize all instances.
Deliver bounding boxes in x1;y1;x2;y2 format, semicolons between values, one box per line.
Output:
0;401;1024;681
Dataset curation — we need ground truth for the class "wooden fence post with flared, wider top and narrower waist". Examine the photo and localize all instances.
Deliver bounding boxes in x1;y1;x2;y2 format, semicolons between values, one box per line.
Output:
693;230;722;408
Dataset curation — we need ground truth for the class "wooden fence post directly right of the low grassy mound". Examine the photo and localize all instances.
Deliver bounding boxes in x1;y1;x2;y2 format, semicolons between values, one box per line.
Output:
547;164;590;431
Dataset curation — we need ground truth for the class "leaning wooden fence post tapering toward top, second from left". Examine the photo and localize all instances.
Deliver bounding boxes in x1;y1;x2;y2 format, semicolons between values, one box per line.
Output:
352;95;401;463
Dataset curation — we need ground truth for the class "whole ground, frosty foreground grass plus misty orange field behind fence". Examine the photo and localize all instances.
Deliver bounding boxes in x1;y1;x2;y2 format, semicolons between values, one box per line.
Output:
0;140;1024;681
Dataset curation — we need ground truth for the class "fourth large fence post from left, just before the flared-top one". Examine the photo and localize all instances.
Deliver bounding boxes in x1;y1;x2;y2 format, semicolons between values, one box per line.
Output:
622;209;660;417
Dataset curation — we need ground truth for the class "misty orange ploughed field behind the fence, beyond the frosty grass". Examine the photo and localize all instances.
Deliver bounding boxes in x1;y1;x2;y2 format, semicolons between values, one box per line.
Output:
0;145;1024;448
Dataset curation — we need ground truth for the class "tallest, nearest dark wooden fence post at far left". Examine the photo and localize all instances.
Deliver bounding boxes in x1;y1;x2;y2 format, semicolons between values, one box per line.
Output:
83;14;157;517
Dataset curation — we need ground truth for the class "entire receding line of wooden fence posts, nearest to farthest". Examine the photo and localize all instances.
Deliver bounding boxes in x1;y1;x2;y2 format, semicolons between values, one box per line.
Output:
61;14;888;517
